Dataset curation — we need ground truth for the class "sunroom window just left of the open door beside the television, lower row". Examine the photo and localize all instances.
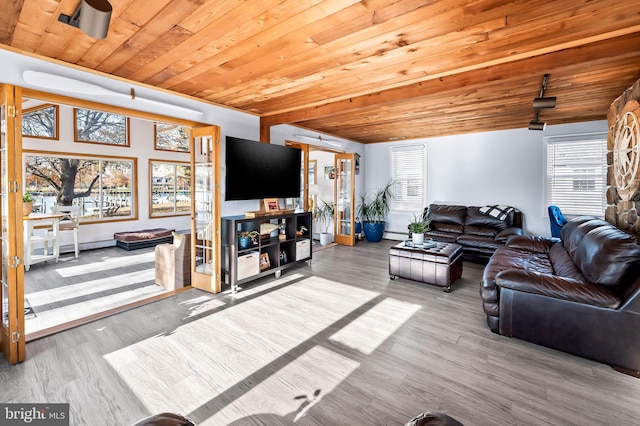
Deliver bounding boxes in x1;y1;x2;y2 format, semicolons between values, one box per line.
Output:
149;160;191;217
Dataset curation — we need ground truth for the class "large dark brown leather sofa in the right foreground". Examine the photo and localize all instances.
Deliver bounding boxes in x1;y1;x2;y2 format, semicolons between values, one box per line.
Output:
480;216;640;372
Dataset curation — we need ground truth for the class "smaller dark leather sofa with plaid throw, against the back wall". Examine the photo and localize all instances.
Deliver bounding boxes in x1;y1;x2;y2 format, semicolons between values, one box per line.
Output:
423;204;522;262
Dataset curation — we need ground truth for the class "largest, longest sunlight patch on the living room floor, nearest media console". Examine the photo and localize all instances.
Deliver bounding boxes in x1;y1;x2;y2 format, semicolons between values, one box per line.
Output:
105;277;379;412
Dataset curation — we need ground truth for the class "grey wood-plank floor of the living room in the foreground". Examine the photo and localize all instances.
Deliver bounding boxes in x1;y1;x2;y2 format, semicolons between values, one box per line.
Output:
0;241;640;426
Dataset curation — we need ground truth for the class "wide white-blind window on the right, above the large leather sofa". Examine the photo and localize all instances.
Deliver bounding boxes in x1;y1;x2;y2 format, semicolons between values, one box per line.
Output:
546;133;607;217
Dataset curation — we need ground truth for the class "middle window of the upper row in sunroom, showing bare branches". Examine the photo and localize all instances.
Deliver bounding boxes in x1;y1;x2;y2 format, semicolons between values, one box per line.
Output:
73;108;129;146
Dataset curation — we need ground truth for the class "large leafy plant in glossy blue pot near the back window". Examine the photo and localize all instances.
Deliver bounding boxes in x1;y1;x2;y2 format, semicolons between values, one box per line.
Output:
358;181;393;243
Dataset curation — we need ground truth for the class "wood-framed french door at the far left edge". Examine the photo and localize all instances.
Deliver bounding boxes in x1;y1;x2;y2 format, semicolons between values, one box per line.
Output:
0;85;26;364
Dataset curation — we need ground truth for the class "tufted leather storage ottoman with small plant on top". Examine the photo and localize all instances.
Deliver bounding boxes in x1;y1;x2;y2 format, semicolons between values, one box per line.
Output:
389;242;462;292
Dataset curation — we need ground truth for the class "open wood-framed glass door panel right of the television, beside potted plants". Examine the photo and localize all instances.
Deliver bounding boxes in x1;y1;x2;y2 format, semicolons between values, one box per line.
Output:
334;154;355;246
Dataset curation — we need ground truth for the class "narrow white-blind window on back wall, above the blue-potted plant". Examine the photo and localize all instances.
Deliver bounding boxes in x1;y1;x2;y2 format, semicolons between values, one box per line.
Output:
391;145;425;212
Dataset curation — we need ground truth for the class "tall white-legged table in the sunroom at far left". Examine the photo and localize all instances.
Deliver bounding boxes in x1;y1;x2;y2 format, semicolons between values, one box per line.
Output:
22;213;67;271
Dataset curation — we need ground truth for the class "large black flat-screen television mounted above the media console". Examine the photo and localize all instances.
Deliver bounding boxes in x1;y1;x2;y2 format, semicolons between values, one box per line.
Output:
225;136;302;201
